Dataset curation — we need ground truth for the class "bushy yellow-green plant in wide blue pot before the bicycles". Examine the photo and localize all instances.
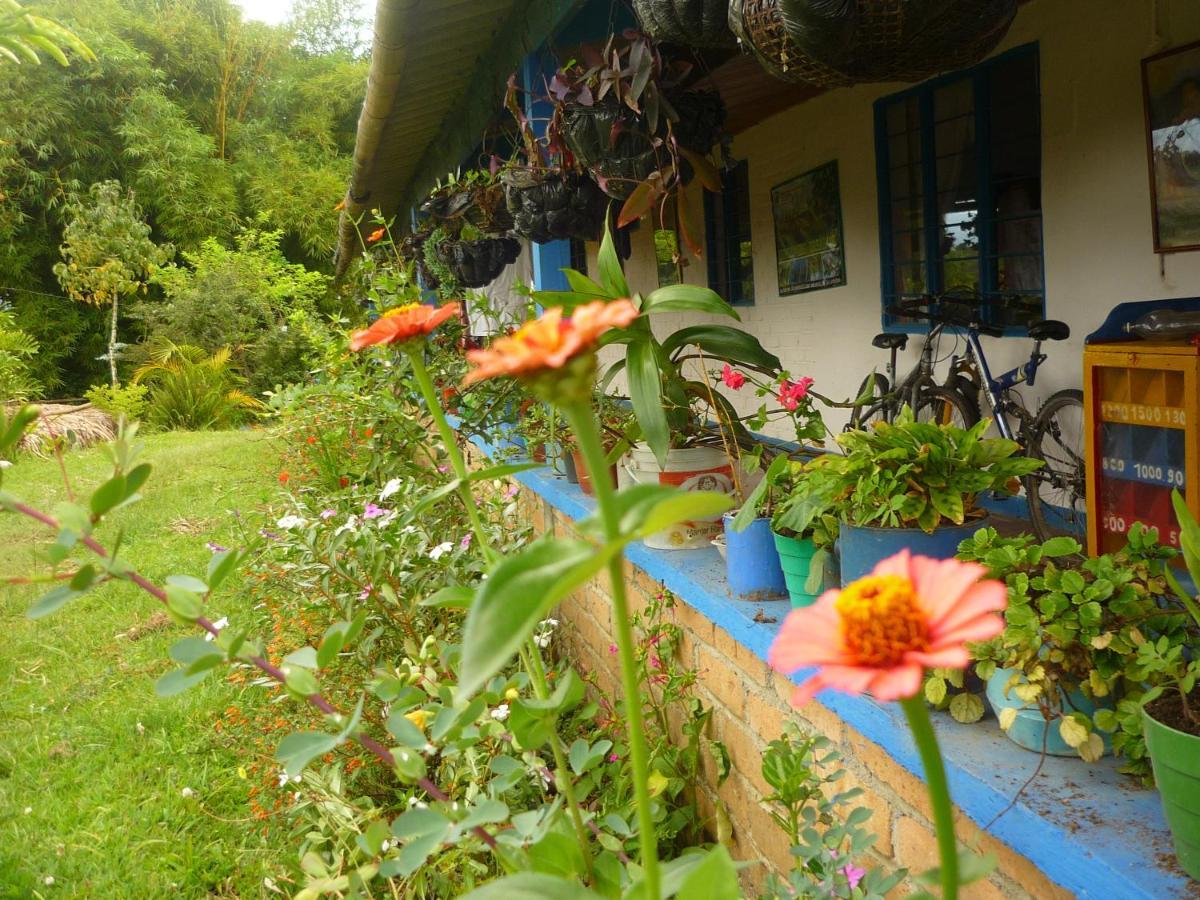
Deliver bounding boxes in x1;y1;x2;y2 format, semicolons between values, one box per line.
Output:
809;408;1042;584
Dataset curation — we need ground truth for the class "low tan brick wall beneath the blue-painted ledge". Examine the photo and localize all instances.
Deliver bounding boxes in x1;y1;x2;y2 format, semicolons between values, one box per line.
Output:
520;490;1070;900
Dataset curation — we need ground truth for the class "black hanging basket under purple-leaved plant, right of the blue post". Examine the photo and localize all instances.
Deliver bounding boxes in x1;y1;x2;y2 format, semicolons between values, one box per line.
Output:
560;98;658;199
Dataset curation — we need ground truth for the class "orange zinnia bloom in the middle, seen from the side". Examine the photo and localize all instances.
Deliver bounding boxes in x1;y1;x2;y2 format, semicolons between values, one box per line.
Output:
462;299;637;386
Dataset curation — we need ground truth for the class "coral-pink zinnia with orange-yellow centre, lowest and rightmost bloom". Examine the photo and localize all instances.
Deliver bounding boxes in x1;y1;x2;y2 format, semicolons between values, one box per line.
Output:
767;550;1008;707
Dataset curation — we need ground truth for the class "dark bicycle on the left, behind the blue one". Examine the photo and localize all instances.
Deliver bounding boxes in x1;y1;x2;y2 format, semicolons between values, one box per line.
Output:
845;294;979;431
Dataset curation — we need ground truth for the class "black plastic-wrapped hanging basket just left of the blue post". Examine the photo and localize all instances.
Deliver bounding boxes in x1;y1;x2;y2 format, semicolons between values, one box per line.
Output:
503;169;608;244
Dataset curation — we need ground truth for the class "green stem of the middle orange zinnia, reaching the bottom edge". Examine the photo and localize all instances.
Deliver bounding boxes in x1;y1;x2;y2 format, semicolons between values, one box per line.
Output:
563;401;661;900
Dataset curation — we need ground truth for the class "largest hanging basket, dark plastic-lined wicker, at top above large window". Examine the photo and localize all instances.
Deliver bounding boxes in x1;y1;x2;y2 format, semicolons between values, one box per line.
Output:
730;0;1016;88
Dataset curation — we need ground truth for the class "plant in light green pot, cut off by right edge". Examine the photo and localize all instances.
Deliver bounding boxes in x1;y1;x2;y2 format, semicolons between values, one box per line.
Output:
1138;491;1200;878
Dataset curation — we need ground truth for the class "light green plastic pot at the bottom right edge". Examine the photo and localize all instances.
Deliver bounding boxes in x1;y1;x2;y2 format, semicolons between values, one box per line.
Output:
1142;709;1200;880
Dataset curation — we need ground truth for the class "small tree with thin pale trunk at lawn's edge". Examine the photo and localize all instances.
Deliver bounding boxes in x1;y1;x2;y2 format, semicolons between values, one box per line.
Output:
54;181;175;388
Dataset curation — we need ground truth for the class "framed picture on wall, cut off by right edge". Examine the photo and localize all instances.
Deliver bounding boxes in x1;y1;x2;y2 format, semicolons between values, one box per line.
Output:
1141;41;1200;253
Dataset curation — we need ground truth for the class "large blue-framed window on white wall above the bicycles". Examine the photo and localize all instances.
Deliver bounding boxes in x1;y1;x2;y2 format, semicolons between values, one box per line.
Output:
875;44;1045;332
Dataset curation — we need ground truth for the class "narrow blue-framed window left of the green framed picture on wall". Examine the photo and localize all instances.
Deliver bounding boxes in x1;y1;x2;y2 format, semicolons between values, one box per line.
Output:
704;160;754;306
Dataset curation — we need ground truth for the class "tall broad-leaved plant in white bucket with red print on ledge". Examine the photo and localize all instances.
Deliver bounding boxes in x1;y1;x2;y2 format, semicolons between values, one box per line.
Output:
534;225;781;550
